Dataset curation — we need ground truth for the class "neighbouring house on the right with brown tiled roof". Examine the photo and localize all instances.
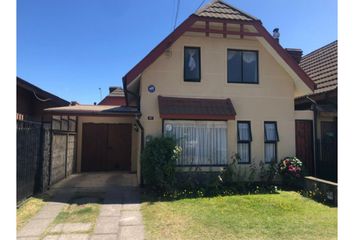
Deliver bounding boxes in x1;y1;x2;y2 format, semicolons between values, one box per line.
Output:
295;41;338;181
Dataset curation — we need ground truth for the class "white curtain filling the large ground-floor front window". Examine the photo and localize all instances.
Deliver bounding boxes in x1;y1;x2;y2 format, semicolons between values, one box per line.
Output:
165;120;227;165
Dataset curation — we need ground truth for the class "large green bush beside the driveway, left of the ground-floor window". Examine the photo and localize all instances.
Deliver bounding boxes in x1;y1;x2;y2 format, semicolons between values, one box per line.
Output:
141;137;181;191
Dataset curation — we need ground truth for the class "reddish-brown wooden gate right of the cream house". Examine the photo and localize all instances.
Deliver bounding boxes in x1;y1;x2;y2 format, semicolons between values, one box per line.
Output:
295;120;314;175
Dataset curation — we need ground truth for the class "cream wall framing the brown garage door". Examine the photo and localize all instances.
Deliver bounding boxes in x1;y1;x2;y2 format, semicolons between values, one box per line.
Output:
77;116;140;178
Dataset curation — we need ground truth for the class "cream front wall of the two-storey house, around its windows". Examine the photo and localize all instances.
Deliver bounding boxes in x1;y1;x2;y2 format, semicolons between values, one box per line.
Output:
140;35;308;172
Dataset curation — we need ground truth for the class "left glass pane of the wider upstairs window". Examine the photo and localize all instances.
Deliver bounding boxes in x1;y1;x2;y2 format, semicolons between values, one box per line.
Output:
227;50;242;82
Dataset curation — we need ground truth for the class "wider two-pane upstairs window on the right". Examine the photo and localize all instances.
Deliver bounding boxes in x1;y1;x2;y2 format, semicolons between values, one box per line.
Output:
227;49;258;84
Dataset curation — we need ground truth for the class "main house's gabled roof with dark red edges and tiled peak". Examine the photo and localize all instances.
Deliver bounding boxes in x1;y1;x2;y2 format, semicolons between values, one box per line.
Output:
123;0;315;91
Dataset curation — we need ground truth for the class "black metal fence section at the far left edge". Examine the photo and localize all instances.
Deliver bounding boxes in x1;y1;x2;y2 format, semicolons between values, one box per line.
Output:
17;121;42;202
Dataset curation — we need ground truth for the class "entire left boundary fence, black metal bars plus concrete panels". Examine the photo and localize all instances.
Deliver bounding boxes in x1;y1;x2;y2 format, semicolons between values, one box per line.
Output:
17;118;77;203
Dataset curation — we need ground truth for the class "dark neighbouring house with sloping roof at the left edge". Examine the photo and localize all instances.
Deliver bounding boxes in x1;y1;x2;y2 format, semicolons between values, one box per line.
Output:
16;77;70;122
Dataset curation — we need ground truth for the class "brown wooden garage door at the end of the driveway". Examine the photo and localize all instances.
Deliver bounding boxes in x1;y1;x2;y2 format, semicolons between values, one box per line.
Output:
82;123;132;172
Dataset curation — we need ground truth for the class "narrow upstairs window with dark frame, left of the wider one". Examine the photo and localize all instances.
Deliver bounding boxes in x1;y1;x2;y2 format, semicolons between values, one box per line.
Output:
184;47;200;82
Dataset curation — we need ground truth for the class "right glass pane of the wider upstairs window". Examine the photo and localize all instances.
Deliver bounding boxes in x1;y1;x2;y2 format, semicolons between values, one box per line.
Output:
242;51;258;83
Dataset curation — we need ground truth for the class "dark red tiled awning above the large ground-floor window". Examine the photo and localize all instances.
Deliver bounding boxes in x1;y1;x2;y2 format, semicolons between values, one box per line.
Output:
158;96;236;120
